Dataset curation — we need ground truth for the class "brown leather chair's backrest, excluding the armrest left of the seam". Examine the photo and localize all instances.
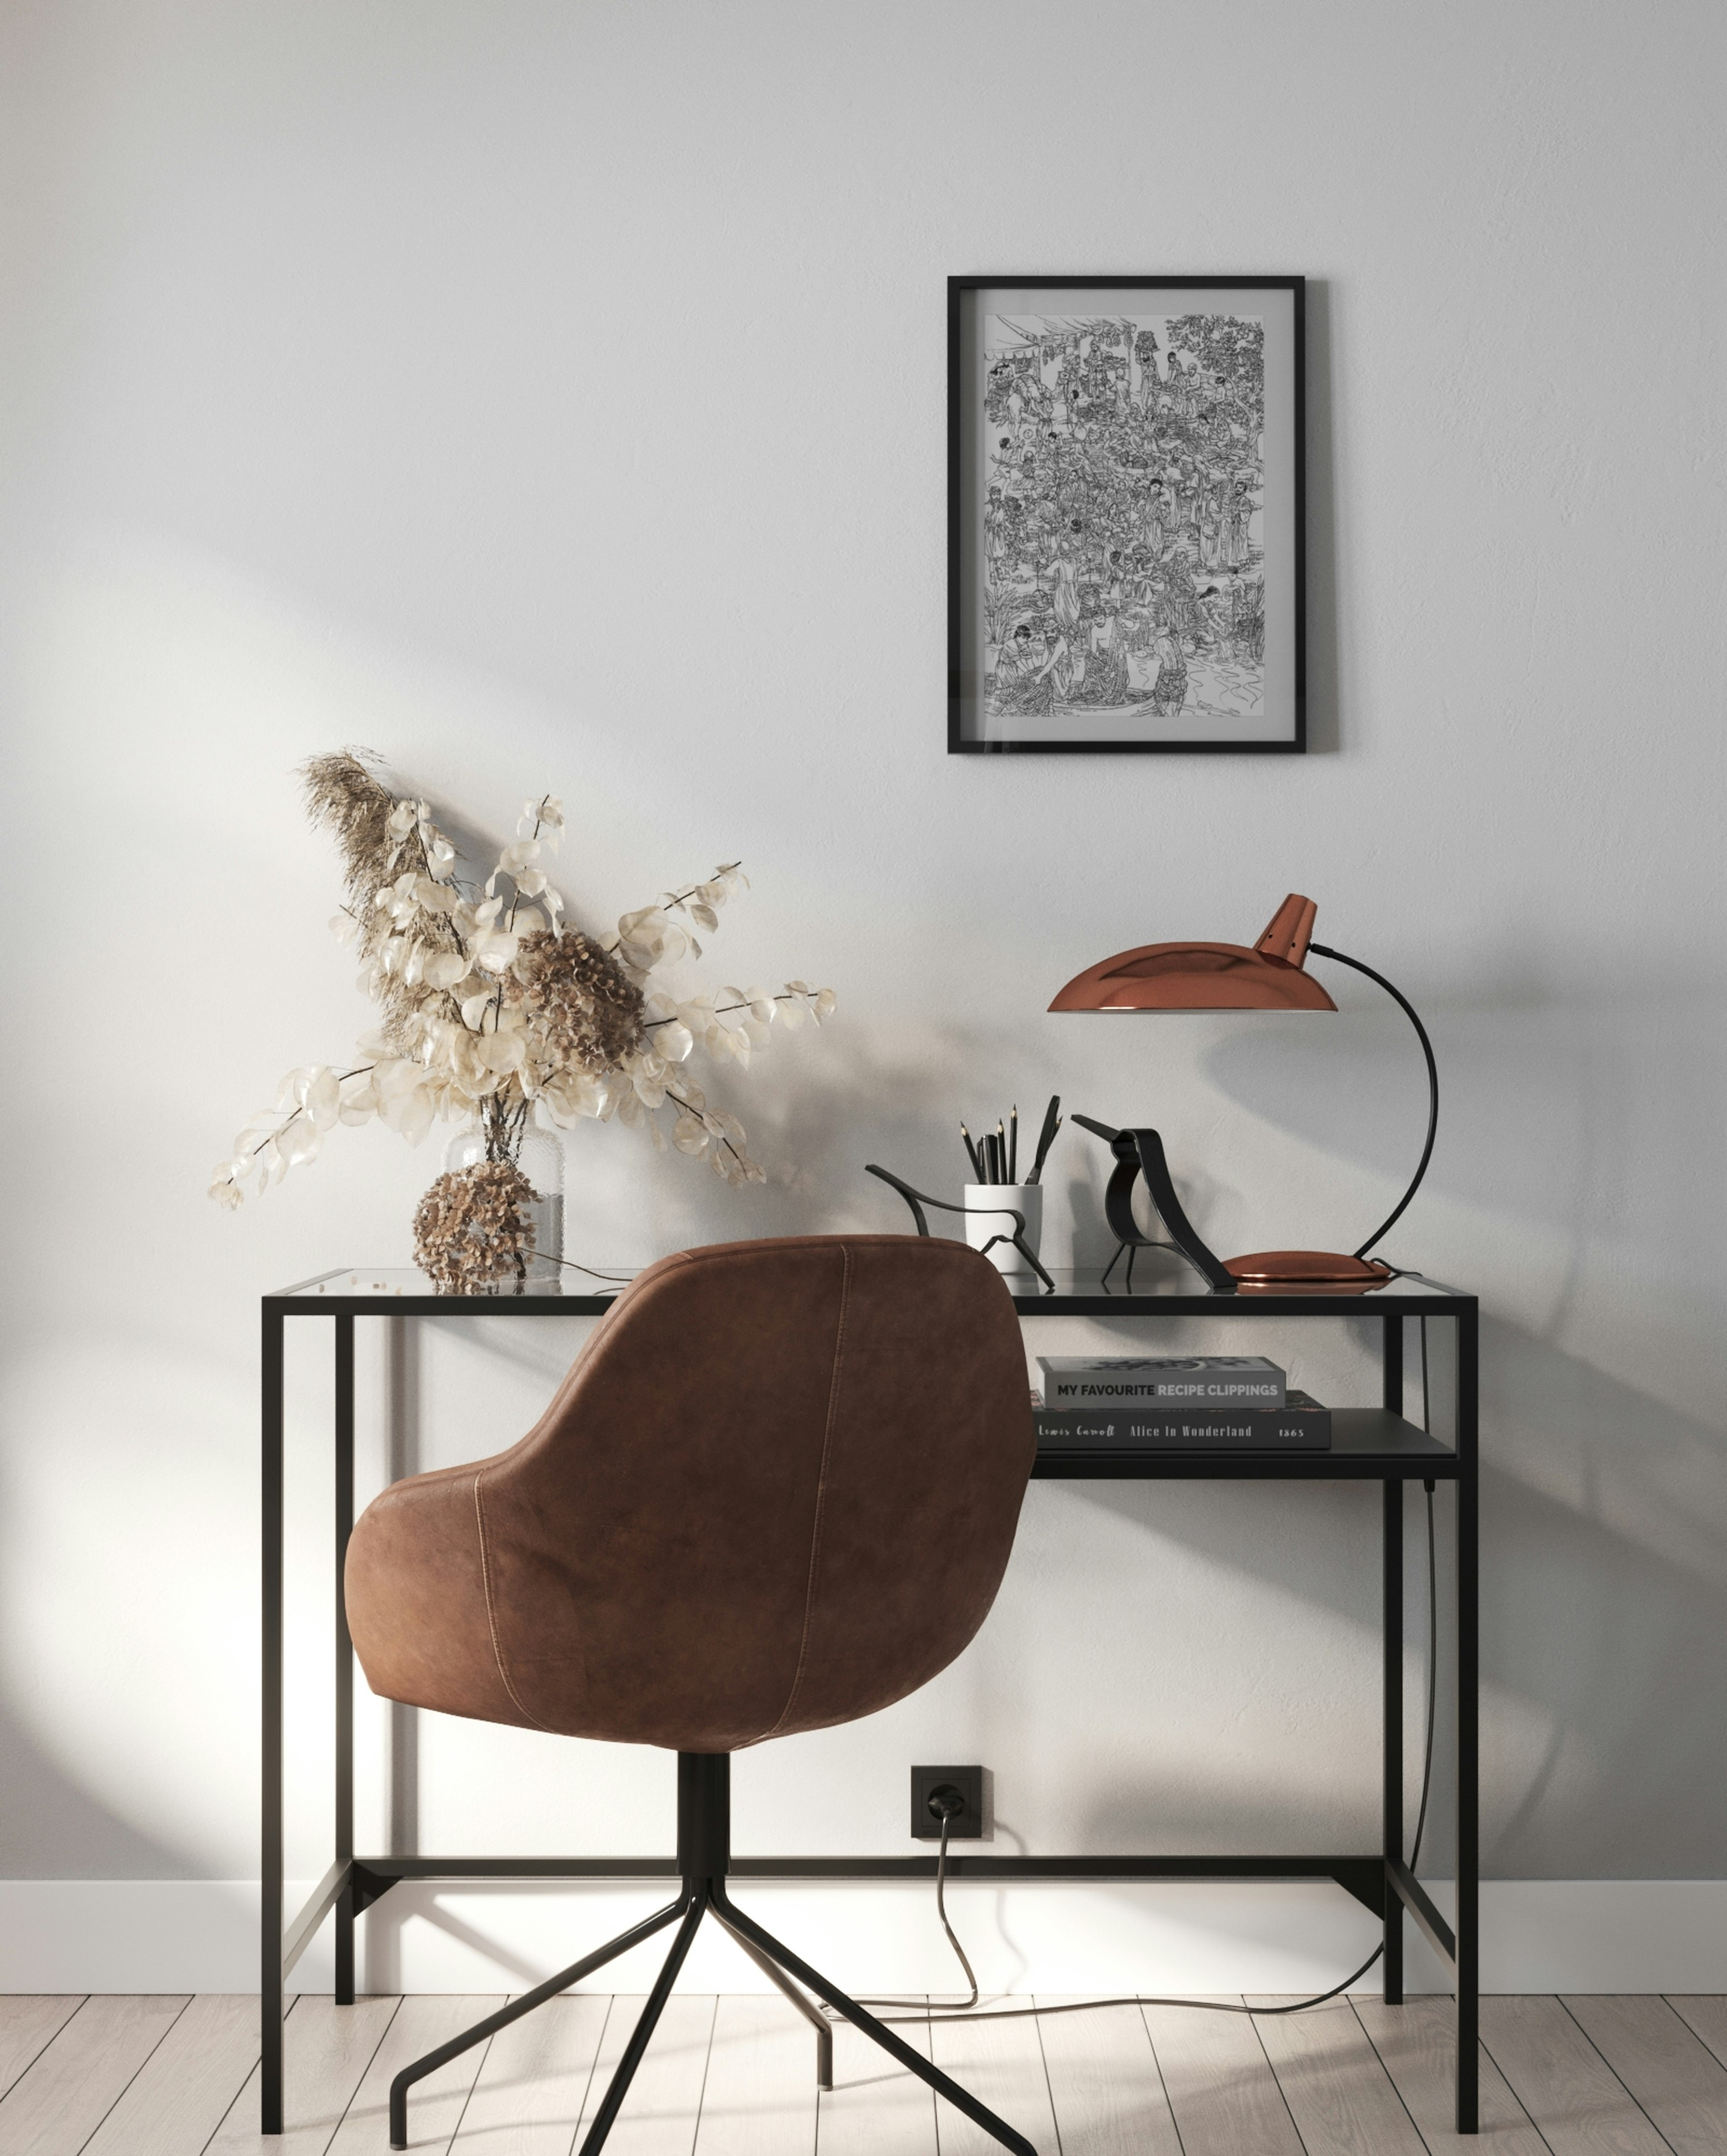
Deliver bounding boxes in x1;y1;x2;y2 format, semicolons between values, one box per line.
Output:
356;1235;1035;1751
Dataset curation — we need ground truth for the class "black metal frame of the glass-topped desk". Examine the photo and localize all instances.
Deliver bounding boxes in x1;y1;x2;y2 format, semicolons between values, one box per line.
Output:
261;1272;1479;2134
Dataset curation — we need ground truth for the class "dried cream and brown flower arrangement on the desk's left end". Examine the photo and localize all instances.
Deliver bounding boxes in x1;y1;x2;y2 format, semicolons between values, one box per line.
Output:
209;750;834;1285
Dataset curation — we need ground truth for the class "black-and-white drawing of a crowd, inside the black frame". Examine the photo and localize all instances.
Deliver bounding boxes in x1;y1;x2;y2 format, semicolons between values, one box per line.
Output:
977;312;1266;727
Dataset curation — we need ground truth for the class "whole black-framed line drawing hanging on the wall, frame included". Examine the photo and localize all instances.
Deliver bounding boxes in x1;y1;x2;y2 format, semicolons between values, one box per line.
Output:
947;276;1307;755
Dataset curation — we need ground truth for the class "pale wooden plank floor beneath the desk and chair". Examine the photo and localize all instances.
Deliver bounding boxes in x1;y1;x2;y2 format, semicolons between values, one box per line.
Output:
0;1997;1727;2156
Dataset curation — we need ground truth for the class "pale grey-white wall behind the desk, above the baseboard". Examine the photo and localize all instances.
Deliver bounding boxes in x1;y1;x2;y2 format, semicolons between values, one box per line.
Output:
0;0;1727;1981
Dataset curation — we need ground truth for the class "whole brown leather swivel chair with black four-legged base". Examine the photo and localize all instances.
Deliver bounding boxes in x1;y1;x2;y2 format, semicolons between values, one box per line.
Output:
347;1235;1033;2156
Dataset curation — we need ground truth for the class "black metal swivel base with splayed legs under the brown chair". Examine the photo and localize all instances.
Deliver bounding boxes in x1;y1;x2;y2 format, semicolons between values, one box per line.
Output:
390;1753;1037;2156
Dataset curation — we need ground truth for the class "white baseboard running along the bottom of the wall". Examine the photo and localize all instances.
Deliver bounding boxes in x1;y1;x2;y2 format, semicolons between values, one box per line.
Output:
0;1880;1727;1992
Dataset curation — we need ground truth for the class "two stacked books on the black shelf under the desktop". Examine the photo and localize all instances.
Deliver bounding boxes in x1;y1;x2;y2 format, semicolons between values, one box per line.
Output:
1031;1354;1330;1453
